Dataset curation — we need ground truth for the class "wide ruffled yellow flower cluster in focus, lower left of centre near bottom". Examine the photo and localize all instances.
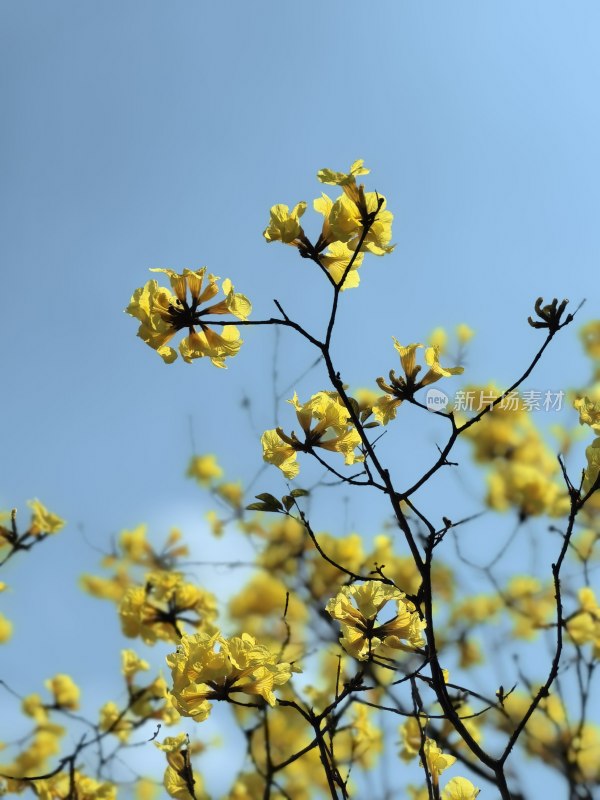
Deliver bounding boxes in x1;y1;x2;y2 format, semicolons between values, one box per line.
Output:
167;633;293;722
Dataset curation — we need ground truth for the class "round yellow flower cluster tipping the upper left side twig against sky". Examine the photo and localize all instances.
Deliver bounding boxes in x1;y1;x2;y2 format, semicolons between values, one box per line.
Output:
125;267;252;367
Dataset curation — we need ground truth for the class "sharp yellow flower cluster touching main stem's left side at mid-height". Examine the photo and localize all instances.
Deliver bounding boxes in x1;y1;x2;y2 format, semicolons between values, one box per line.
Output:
261;392;364;478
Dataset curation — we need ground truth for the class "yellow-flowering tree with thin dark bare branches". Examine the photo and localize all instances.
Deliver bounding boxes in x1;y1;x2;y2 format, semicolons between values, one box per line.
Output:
0;161;600;800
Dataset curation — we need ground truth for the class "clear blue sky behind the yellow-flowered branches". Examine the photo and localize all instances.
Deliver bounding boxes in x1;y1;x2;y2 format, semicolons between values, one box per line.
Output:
0;0;600;797
